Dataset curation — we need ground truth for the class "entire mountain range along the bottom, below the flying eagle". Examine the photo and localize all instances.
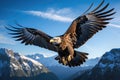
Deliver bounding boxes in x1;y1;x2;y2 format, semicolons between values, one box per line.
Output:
0;48;120;80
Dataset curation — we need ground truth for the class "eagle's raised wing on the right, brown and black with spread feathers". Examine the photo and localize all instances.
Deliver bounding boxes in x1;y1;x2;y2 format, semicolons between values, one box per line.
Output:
65;0;115;48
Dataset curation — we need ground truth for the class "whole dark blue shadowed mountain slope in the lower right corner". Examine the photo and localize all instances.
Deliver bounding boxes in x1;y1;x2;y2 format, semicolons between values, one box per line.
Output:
75;49;120;80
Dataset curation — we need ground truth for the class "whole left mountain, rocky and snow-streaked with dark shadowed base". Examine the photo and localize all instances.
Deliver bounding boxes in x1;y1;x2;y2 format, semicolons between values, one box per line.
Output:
0;48;58;80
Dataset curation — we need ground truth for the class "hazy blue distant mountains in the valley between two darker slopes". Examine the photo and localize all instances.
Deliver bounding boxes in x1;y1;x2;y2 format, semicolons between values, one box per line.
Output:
26;54;100;80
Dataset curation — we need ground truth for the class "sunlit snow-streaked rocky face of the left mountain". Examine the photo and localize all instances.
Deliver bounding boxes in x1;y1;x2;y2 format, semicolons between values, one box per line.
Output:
11;54;43;71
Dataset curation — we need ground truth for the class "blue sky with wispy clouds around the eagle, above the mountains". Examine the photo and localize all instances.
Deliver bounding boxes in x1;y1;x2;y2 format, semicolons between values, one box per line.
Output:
0;0;120;58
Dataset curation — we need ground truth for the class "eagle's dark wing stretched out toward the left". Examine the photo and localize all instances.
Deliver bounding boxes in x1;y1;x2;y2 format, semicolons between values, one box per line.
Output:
6;24;57;51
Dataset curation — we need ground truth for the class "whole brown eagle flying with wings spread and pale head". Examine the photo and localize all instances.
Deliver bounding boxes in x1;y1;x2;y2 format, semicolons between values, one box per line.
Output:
6;0;115;67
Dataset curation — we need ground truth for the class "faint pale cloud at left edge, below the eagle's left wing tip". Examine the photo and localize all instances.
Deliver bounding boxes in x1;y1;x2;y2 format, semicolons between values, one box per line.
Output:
0;34;15;45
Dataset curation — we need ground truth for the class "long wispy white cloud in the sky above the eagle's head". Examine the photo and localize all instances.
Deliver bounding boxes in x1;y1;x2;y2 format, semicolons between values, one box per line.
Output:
24;8;73;22
